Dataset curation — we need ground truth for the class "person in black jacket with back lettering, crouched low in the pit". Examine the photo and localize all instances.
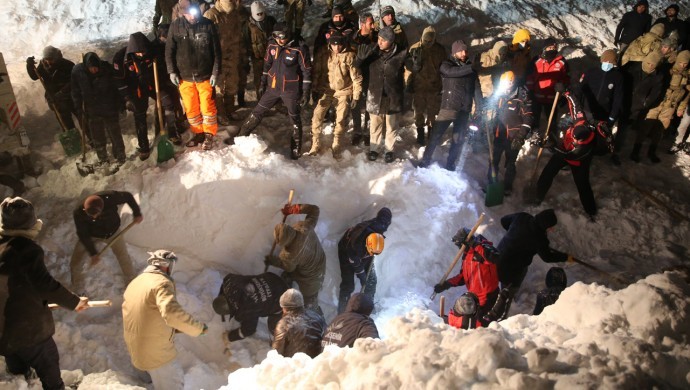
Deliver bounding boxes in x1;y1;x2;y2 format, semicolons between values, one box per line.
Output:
213;272;288;341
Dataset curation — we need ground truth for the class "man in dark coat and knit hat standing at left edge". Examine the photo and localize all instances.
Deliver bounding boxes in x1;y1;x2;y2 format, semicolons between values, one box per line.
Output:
0;197;89;389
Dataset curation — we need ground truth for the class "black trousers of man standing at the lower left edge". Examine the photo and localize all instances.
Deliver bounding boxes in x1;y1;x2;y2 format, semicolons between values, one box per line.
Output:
5;337;65;390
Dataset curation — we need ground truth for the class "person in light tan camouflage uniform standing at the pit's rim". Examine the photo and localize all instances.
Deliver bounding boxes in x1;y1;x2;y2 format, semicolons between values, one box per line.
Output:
309;33;362;159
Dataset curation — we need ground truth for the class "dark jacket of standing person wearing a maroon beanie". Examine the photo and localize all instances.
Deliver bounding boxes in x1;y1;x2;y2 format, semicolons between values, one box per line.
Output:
440;58;484;112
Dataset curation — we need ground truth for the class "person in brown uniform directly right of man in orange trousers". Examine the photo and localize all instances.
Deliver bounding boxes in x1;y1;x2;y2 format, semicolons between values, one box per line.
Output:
204;0;247;126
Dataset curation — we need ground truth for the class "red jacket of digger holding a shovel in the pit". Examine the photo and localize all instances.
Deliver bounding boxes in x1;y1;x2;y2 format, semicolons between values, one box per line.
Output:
448;243;498;308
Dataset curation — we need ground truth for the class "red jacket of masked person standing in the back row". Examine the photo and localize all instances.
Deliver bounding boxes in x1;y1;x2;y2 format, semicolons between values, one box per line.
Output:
526;55;570;104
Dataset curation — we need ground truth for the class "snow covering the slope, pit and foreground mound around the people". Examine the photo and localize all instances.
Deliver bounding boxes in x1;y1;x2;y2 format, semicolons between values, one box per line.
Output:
0;0;690;389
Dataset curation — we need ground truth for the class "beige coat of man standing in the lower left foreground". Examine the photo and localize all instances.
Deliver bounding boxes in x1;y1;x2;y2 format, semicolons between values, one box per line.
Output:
122;266;204;371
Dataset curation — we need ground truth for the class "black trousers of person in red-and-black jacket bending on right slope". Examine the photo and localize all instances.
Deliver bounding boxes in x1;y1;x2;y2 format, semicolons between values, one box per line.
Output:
537;152;597;215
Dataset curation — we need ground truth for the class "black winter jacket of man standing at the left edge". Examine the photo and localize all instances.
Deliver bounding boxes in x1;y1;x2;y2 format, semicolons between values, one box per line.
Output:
0;236;79;356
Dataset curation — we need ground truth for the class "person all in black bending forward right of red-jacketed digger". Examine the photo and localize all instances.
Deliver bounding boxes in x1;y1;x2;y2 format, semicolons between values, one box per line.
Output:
482;209;574;323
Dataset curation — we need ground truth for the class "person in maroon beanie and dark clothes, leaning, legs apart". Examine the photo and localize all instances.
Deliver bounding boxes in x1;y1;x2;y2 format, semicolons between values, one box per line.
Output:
419;40;484;171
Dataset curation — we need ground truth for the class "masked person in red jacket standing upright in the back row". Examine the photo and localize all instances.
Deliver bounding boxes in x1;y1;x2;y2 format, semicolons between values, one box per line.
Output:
526;37;570;139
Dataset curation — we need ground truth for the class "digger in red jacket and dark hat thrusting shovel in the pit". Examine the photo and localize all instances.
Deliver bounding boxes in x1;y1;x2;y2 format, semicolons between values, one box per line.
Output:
434;228;499;317
